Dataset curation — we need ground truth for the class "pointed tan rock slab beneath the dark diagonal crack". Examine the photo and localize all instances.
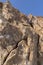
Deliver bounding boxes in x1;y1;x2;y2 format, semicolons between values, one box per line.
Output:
4;40;28;65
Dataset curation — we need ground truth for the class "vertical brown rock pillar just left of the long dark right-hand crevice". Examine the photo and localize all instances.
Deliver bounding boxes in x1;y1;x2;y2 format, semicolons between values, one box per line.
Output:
29;34;38;65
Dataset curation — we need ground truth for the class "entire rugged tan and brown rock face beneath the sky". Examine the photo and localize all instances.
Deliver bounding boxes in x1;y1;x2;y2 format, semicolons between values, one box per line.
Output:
0;2;43;65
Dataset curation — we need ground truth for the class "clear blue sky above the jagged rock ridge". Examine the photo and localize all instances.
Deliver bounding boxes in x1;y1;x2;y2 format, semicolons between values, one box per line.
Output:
0;0;43;16
